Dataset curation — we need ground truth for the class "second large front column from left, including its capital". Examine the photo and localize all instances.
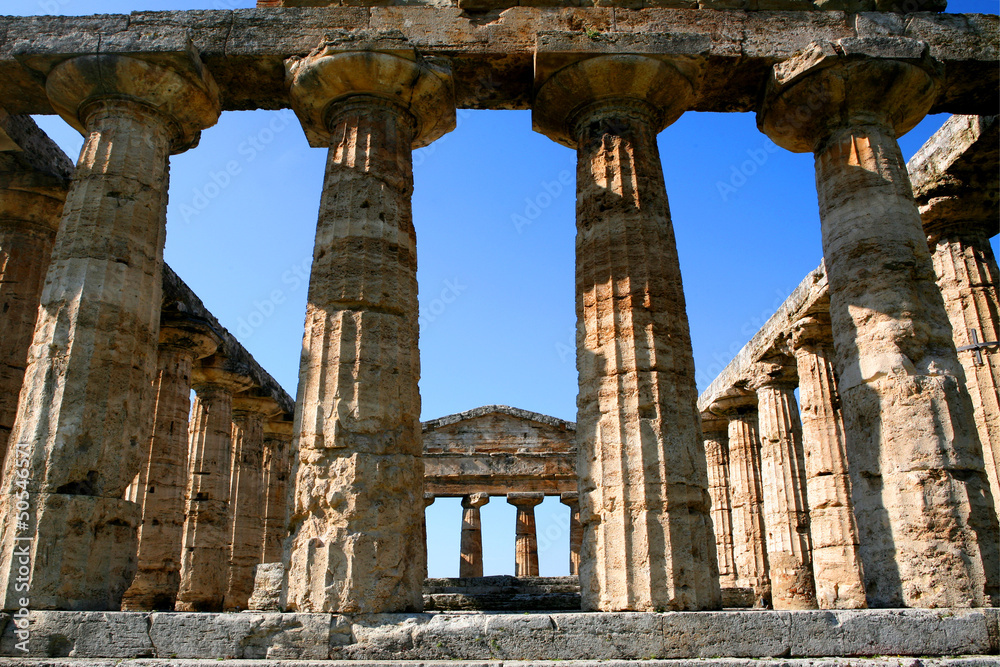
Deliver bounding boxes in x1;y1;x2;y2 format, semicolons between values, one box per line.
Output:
287;44;455;613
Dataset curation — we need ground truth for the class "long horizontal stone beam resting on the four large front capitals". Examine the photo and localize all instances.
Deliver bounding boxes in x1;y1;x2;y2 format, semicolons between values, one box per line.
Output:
0;6;1000;114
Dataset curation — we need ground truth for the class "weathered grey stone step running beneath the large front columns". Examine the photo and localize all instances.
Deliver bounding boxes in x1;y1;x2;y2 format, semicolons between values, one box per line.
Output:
0;609;1000;667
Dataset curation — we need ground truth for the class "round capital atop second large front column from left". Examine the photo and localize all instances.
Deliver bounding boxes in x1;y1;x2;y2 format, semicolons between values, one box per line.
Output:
285;46;456;148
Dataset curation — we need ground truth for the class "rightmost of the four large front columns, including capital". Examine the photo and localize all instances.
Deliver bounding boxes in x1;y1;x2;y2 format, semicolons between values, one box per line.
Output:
757;37;1000;607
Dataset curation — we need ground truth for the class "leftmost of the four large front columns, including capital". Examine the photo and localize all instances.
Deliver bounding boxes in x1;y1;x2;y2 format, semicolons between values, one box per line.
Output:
0;53;220;610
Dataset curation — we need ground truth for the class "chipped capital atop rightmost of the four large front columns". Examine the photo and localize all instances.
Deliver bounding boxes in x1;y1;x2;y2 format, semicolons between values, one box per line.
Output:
757;36;940;153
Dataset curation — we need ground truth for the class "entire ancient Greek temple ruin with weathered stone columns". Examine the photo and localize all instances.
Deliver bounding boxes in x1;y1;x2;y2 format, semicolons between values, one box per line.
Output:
0;0;1000;664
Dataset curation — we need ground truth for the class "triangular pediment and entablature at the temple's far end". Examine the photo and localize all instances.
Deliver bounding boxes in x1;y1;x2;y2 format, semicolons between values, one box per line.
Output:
423;405;577;497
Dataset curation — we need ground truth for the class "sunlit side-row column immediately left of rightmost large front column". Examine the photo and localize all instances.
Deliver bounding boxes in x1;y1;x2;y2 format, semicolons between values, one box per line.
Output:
792;314;867;609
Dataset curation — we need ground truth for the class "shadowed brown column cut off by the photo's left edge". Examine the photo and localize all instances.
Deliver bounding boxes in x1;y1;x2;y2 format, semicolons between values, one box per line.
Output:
0;188;63;461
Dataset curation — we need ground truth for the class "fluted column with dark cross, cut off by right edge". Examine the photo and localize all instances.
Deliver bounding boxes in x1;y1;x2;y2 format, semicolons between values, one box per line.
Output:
923;217;1000;515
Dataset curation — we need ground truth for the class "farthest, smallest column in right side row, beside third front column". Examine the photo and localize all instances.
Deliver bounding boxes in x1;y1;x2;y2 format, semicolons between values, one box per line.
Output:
701;411;736;588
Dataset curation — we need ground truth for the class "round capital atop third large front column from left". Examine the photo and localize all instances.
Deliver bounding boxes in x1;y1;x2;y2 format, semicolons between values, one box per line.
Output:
531;53;699;149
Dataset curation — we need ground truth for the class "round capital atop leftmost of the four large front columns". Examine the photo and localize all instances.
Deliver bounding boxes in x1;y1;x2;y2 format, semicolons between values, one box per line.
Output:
45;49;222;153
